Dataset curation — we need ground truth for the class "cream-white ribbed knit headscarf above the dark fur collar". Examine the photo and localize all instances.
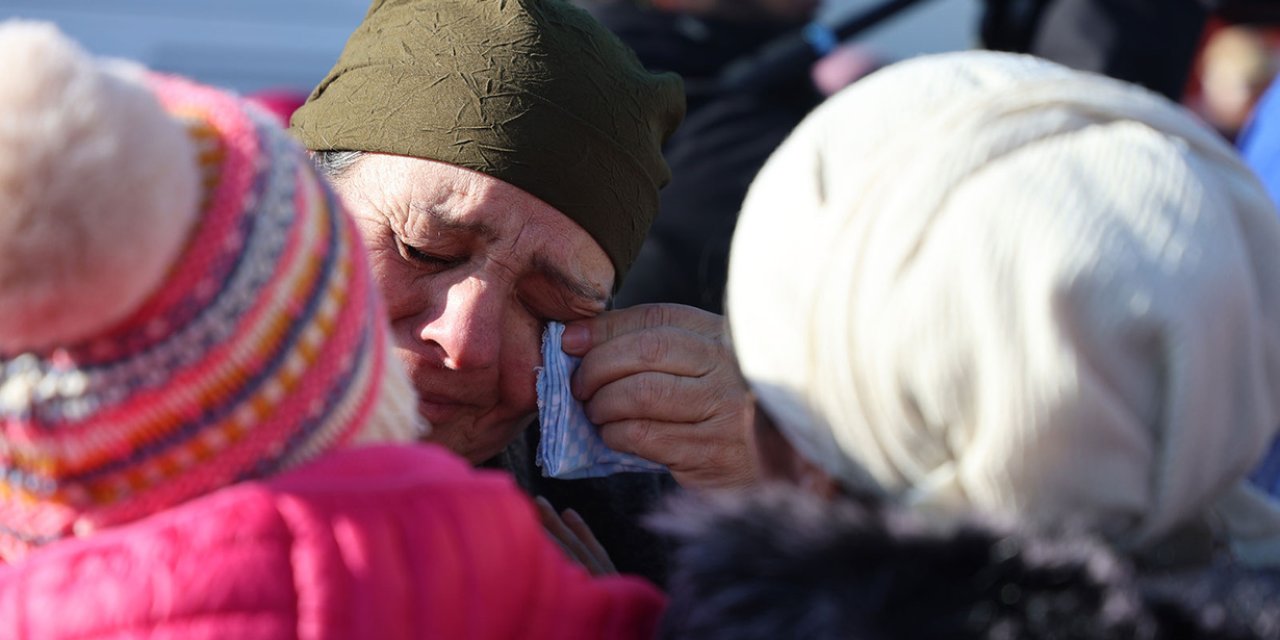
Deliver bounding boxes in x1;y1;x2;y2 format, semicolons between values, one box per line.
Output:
727;51;1280;563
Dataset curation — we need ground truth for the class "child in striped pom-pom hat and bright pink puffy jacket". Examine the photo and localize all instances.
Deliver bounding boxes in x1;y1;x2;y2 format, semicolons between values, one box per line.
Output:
0;22;662;640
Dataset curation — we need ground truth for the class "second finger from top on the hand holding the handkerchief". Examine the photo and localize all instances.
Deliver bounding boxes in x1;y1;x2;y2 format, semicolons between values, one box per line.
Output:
570;326;732;401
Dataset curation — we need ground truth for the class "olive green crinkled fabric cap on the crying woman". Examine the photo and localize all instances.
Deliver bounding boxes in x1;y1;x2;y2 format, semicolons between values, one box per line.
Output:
293;0;685;282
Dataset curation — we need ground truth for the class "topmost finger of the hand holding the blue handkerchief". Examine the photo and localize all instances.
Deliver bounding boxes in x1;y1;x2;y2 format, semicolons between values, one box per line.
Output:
561;303;724;356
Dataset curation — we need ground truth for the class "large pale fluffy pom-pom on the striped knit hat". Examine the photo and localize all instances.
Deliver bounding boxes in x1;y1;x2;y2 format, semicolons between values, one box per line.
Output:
0;20;200;353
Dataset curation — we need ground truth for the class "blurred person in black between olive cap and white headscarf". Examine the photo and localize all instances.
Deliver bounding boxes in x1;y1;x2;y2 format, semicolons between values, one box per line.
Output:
580;0;876;314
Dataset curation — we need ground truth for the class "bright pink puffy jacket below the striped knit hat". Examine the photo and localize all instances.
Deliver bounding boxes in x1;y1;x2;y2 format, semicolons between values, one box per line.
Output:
0;445;663;640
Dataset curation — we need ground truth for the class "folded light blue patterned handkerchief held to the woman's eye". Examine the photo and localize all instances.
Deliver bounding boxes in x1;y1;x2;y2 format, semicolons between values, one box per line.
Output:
538;323;667;479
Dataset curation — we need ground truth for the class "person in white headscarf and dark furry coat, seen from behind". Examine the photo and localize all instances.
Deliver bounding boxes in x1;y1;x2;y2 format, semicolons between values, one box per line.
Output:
664;51;1280;639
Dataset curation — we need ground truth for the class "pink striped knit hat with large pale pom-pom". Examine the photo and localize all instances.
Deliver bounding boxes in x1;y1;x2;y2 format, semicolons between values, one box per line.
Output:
0;22;424;559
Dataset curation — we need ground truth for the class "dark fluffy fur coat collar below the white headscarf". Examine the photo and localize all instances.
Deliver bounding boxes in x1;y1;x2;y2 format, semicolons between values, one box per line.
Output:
655;488;1280;640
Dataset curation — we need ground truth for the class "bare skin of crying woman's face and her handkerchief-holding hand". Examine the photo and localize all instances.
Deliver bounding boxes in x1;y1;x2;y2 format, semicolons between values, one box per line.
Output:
335;154;756;488
